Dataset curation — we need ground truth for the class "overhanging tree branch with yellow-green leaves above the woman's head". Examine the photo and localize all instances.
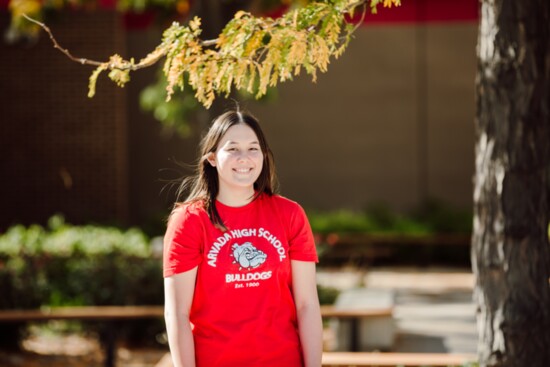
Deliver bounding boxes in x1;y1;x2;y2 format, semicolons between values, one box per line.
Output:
23;0;400;108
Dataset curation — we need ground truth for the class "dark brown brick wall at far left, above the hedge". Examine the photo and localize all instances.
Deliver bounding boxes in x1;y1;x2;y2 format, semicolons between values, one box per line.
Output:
0;12;128;229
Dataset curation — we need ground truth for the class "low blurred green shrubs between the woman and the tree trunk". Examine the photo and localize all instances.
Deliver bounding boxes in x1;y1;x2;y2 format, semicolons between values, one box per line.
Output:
307;199;474;266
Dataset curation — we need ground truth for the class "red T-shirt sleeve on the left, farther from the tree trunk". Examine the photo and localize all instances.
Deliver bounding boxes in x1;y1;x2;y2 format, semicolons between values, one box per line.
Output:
163;205;207;278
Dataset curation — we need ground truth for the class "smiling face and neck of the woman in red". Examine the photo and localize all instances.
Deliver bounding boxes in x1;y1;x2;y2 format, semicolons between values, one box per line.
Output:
208;123;264;201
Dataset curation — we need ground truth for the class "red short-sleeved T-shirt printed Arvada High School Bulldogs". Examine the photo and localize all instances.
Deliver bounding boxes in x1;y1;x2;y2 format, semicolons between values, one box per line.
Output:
163;194;317;367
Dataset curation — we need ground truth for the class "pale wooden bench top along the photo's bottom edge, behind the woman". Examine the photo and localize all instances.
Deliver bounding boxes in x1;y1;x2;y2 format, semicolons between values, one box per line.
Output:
155;352;476;367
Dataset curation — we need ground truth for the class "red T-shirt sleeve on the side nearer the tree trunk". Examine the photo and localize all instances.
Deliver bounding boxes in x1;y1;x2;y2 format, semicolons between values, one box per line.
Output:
289;204;319;262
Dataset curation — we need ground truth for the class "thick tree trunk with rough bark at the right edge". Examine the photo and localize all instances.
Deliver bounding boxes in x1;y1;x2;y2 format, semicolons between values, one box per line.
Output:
472;0;550;367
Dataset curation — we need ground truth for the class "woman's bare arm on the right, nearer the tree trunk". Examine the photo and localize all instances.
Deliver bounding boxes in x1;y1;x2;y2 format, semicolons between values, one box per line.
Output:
291;260;323;367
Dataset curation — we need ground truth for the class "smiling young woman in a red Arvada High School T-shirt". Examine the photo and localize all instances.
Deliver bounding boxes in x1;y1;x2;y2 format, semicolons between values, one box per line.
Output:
163;111;322;367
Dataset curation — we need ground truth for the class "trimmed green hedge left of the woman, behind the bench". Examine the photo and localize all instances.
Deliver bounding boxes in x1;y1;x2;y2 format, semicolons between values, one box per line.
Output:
0;216;163;345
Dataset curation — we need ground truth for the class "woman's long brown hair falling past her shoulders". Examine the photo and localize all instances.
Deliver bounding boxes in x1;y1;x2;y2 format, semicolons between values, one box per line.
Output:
176;111;277;231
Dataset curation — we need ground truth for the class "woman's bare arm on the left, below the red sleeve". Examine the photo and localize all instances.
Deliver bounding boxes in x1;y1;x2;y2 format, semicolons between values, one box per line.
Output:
164;267;197;367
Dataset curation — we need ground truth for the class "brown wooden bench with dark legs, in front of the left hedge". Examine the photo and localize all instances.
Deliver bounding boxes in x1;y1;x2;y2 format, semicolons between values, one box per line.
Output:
0;306;392;367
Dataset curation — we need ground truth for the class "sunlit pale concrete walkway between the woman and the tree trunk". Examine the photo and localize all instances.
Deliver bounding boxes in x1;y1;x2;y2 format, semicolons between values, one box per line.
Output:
317;268;477;354
